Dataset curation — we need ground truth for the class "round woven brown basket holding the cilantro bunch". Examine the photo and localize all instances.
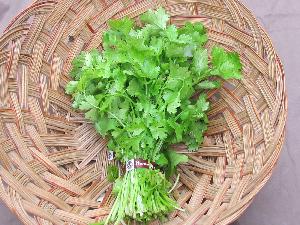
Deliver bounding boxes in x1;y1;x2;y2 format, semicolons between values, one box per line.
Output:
0;0;287;225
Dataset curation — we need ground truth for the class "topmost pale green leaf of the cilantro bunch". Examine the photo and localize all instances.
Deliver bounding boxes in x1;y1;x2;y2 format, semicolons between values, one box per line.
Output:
140;7;169;29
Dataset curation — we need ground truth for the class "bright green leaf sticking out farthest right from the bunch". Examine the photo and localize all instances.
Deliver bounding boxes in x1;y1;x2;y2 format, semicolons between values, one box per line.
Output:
211;47;242;79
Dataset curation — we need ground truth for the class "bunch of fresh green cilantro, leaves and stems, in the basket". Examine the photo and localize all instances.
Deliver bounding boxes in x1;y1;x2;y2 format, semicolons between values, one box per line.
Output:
66;8;242;224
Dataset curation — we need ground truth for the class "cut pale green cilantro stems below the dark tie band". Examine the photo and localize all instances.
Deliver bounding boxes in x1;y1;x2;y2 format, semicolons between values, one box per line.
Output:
105;169;178;225
